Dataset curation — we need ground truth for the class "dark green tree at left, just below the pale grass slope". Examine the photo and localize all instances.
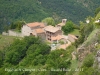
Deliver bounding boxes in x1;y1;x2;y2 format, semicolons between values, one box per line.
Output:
5;40;27;65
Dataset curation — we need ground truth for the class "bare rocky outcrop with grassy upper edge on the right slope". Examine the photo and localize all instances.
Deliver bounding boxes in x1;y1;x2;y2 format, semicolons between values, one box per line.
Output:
77;29;100;61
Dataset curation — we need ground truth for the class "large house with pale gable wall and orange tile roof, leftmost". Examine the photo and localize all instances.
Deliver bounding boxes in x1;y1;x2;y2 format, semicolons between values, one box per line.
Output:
21;22;45;36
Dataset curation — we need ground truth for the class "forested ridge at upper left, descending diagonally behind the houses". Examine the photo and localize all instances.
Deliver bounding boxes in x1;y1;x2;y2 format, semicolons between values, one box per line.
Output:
0;0;49;30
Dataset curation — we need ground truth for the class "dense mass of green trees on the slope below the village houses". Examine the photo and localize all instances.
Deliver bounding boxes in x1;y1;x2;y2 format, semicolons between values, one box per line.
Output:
0;36;75;75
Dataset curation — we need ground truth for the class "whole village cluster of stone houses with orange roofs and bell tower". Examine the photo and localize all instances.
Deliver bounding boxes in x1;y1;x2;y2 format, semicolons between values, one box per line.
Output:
2;19;78;50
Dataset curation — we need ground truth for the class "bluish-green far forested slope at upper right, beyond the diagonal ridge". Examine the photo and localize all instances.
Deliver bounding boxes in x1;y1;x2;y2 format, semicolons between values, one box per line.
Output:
39;0;100;23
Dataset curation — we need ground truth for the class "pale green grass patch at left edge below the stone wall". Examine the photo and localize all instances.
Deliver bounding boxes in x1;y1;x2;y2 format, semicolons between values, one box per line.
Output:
0;35;19;50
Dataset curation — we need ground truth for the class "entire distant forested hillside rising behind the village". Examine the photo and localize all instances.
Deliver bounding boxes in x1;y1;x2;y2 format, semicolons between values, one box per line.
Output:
0;0;100;31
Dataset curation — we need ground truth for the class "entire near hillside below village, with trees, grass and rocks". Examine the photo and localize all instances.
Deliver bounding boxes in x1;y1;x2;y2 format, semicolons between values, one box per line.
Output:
0;13;100;75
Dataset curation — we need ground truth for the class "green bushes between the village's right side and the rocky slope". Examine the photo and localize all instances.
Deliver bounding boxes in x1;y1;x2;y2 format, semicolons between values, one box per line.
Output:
75;17;95;47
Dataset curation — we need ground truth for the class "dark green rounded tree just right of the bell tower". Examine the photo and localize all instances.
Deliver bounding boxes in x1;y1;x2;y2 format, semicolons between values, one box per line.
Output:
62;21;74;34
